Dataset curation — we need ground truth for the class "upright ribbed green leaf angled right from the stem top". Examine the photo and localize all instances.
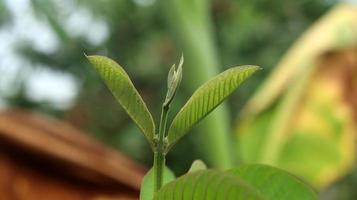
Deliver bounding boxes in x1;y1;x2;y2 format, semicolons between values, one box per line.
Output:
168;66;259;148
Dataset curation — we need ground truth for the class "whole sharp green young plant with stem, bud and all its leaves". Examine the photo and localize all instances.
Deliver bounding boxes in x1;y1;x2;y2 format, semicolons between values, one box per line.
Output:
87;56;317;200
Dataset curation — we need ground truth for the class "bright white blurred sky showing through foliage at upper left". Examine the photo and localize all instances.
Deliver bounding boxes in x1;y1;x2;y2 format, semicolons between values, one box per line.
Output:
0;0;109;109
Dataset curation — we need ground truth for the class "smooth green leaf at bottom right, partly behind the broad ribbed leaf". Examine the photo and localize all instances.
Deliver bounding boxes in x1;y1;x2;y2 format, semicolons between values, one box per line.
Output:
228;164;317;200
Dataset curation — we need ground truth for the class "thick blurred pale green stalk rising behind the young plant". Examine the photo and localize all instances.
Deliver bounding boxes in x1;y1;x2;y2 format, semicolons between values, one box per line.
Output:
160;0;234;169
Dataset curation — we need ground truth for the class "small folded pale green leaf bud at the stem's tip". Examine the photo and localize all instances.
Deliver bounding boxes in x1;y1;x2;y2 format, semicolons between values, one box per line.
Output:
164;56;184;106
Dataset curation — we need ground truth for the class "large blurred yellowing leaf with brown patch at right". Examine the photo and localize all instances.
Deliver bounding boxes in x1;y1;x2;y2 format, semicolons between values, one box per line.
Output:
236;5;357;189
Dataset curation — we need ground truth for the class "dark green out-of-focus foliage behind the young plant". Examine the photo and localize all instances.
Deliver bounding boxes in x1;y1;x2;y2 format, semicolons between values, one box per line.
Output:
0;0;334;174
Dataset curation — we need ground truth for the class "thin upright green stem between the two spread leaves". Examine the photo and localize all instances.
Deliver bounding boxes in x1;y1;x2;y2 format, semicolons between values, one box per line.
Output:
154;106;169;192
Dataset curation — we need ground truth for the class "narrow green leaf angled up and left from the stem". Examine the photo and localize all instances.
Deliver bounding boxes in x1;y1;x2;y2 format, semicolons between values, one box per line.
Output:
87;56;155;145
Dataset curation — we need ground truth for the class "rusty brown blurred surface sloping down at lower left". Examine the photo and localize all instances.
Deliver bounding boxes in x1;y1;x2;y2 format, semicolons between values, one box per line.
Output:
0;110;145;200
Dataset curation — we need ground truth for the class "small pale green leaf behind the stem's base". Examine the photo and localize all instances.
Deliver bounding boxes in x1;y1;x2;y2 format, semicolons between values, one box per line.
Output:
140;167;176;200
